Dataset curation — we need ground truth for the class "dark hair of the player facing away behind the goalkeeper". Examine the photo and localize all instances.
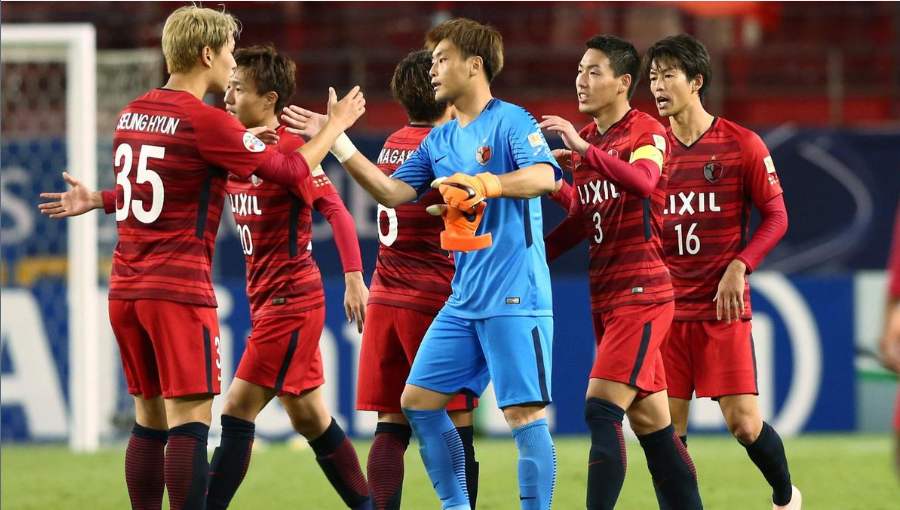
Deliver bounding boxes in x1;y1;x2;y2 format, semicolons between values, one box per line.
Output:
391;50;447;123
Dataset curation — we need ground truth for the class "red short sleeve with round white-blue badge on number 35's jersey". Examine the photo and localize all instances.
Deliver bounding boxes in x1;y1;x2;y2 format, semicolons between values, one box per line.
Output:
192;107;271;179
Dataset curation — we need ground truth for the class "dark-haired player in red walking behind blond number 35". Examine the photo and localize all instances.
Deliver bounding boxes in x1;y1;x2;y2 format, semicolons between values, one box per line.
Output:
206;46;369;509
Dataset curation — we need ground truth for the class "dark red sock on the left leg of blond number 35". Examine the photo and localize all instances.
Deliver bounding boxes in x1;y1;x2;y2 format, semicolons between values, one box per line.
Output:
125;423;168;510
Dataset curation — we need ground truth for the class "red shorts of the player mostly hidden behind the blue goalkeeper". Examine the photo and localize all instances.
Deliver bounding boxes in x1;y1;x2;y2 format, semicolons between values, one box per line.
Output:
356;303;478;413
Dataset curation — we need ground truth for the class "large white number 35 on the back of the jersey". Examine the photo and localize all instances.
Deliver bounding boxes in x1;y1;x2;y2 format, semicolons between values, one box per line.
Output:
115;143;166;223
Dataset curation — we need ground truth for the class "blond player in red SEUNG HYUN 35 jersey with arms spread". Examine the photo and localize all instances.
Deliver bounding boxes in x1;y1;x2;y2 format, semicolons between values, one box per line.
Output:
36;6;365;509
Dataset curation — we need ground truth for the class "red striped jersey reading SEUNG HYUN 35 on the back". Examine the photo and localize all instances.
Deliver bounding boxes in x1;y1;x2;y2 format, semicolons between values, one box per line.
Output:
109;89;271;306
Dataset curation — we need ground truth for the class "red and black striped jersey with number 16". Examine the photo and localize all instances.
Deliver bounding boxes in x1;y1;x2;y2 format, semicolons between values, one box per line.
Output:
663;118;783;320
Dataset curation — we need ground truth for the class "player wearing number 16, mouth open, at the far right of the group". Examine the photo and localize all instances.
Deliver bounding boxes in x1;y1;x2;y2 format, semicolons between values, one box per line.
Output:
644;35;801;509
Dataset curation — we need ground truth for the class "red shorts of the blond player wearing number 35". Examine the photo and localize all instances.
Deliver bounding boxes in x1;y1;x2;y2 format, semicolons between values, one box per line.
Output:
109;299;222;399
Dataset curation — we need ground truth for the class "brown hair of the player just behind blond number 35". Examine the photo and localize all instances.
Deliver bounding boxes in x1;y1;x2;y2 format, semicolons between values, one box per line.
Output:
234;44;297;114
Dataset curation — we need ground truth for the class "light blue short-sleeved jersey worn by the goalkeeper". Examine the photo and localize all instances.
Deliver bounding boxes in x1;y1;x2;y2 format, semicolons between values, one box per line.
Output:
392;99;562;319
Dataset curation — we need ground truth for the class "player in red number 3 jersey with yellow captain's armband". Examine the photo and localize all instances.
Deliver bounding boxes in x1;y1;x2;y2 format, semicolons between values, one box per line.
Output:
541;36;702;509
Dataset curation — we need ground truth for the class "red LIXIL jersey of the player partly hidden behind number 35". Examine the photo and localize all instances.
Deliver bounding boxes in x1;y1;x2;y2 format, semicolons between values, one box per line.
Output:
228;127;337;318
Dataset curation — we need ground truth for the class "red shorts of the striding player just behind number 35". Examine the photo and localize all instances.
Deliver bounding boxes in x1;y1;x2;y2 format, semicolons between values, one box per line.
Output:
234;306;325;395
